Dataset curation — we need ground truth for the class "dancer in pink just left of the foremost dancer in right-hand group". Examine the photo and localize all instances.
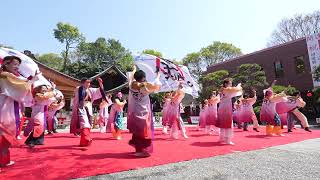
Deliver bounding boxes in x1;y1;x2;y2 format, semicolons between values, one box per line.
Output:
206;91;220;134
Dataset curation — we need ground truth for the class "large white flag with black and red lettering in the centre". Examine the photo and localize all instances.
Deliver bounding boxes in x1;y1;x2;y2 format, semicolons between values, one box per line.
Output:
134;54;199;97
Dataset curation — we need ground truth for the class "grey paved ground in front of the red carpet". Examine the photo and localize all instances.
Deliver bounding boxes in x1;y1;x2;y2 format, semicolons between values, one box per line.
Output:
77;138;320;180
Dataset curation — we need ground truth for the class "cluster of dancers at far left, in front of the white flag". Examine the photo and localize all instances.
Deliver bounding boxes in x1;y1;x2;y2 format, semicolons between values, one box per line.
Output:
0;56;64;167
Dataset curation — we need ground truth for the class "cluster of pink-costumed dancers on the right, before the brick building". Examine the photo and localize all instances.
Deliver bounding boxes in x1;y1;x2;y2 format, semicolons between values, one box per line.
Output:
195;78;311;145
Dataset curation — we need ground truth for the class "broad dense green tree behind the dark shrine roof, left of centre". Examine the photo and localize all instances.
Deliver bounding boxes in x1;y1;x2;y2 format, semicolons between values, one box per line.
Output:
68;37;133;77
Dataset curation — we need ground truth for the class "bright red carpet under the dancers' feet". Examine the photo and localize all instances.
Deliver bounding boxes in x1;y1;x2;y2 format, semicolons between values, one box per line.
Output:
0;128;320;180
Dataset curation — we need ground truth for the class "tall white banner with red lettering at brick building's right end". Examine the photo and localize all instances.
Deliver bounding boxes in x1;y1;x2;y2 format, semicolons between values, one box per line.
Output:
306;33;320;87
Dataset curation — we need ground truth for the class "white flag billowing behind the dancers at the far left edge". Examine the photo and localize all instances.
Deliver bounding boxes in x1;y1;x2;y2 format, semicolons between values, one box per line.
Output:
0;47;51;87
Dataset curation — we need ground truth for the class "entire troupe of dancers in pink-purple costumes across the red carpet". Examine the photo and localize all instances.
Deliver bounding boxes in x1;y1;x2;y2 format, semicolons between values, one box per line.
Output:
0;56;316;167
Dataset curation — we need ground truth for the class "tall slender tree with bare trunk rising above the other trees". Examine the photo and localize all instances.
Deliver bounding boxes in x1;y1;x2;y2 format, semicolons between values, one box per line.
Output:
53;22;84;71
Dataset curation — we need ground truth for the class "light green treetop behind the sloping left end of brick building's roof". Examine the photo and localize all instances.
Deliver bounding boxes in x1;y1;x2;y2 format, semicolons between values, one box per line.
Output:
200;41;242;68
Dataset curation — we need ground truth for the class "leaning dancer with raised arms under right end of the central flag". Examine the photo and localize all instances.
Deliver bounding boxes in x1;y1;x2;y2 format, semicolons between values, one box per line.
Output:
167;83;188;139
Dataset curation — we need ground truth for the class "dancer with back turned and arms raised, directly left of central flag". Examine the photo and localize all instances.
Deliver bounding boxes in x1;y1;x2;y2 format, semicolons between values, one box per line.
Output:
128;67;161;157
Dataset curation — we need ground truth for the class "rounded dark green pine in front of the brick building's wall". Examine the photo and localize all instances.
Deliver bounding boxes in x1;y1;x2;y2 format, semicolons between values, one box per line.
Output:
233;64;268;91
